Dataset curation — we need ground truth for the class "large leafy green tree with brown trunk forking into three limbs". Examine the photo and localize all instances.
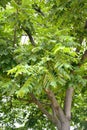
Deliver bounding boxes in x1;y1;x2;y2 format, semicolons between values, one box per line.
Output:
0;0;87;130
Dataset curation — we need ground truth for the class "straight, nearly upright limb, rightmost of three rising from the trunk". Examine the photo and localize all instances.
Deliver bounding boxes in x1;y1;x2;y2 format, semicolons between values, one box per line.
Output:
64;87;74;120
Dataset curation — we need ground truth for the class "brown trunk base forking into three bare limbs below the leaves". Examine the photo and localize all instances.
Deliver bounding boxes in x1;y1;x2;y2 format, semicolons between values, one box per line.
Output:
29;87;73;130
